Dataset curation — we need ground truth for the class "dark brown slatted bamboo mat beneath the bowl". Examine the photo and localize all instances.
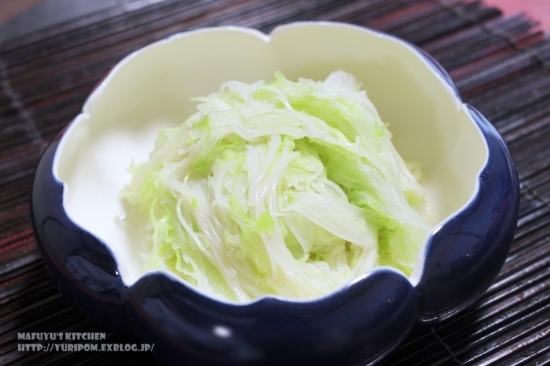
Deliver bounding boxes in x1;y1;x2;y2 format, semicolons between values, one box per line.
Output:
0;0;550;366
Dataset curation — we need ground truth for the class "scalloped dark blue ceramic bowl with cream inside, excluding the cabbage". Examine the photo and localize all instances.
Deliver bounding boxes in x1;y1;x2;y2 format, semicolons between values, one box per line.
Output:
32;22;519;365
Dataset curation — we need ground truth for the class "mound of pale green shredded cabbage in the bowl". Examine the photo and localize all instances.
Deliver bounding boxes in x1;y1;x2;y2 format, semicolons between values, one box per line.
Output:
123;71;429;302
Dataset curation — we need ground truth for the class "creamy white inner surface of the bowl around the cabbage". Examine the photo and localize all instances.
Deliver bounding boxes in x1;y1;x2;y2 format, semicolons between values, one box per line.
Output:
54;23;487;285
